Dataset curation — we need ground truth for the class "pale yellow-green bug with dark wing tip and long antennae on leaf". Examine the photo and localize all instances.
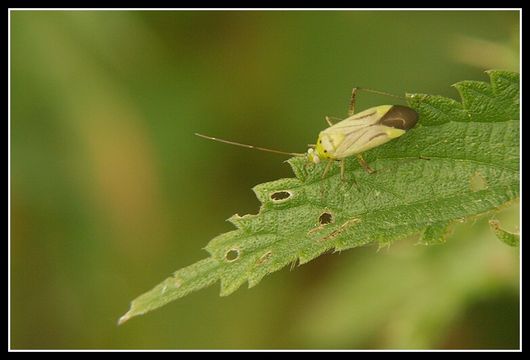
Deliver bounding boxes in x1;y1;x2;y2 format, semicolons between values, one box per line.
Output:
195;88;418;179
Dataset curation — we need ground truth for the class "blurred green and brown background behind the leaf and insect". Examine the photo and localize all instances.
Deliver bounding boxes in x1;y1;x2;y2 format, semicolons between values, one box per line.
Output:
10;11;519;349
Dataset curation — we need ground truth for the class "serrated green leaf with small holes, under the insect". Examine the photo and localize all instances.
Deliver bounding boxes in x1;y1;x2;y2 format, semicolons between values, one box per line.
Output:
119;71;519;323
